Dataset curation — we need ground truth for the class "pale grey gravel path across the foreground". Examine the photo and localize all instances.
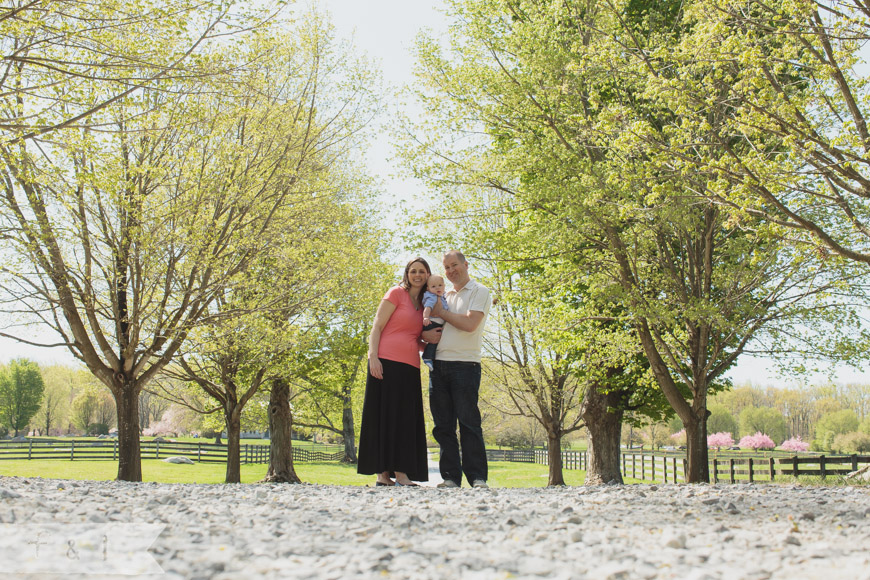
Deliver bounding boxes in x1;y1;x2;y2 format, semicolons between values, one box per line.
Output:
0;477;870;580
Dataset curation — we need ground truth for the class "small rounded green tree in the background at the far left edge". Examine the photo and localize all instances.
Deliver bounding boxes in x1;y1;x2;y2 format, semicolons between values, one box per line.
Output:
0;359;45;437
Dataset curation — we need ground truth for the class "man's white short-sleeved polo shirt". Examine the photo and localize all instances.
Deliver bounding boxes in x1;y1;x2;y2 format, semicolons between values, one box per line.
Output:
435;280;492;363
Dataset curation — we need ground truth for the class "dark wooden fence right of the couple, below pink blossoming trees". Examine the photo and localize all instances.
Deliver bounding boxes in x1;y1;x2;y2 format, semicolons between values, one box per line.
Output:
486;449;870;483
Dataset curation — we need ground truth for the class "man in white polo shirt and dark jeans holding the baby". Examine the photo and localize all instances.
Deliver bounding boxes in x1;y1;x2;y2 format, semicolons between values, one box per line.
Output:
429;250;492;487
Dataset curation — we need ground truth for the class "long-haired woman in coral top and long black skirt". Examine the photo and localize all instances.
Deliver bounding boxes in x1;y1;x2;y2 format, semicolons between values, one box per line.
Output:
357;258;431;485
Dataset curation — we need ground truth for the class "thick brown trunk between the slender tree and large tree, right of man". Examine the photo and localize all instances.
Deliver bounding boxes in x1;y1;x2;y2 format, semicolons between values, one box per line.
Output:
582;385;623;485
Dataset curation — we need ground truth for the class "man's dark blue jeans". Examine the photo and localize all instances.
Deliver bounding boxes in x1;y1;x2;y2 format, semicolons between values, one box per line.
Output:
429;360;489;484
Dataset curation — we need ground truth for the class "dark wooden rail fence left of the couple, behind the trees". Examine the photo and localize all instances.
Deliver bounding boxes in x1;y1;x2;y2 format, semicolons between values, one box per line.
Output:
0;439;344;464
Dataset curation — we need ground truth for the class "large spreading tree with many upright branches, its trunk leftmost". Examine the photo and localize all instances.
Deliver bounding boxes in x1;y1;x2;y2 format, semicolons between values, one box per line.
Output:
0;2;382;481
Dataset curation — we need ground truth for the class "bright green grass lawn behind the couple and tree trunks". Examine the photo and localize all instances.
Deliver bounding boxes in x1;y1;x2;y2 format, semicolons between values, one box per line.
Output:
0;459;633;487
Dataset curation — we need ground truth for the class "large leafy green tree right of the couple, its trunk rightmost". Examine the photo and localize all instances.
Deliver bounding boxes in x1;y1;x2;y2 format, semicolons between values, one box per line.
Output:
408;0;852;481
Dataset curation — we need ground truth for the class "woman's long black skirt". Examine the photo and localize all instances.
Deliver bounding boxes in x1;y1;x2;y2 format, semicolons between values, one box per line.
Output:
357;359;429;481
